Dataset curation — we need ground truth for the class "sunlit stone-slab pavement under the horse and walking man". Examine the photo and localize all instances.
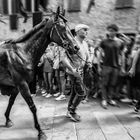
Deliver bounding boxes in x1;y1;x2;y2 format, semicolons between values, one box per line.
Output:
0;95;140;140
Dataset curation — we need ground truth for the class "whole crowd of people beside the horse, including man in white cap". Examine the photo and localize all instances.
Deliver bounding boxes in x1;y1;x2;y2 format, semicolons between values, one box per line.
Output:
32;24;140;121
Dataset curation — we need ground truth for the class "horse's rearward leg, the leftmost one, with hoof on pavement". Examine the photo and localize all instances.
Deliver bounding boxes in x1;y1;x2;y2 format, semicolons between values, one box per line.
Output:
5;88;18;127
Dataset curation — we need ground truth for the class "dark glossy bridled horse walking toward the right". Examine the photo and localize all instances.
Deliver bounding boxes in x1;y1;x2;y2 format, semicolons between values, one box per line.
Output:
0;8;78;140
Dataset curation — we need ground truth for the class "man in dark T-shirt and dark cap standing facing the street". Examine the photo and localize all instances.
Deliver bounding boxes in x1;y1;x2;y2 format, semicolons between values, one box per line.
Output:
100;24;124;109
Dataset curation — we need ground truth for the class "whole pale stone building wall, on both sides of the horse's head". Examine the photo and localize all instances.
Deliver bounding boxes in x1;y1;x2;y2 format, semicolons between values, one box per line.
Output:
0;0;140;40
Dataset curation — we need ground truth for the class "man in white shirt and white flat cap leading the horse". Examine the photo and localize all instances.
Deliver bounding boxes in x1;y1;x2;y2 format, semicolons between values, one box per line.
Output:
64;24;90;122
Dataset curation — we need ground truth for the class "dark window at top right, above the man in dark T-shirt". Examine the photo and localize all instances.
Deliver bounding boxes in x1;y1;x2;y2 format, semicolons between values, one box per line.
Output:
115;0;133;9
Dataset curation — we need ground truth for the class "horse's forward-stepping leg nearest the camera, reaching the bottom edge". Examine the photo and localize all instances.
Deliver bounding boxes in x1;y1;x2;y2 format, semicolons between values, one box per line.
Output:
19;81;47;140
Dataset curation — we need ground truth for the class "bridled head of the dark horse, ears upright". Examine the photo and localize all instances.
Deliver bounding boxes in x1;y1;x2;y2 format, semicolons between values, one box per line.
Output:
50;7;79;54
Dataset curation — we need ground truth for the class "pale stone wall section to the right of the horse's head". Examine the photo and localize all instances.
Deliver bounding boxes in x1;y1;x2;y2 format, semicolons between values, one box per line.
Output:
64;0;140;38
